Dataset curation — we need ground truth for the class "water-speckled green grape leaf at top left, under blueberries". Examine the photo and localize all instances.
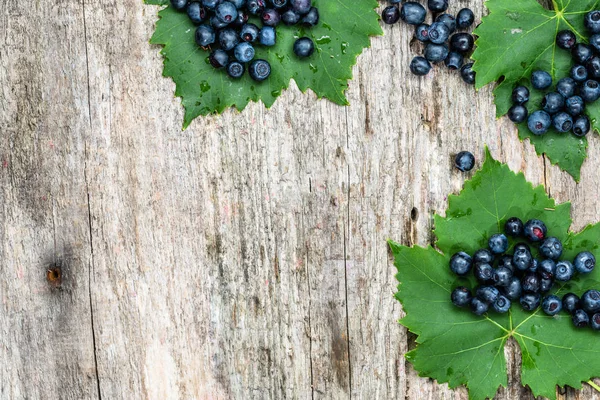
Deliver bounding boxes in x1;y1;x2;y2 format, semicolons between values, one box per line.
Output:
146;0;383;128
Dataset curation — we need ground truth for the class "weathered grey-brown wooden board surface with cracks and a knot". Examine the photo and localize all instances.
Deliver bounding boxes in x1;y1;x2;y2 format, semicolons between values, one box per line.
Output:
0;0;600;399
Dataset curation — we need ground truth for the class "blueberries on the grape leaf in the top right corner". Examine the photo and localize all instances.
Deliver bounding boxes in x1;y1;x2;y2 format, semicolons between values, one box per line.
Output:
508;11;600;137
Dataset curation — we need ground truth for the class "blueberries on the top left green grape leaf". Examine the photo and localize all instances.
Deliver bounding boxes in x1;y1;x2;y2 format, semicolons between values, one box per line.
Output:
171;0;319;82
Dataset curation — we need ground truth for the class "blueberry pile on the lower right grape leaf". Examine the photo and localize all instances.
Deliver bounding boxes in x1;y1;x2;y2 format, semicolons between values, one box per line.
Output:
450;217;600;330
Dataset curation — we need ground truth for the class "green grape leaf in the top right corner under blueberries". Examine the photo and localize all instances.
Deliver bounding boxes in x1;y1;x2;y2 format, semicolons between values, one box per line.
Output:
473;0;600;181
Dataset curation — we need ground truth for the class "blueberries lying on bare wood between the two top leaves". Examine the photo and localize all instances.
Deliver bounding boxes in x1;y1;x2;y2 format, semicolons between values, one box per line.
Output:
381;0;475;84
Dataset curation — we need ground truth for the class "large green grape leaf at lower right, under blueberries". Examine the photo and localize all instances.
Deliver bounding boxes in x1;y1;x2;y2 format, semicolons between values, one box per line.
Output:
389;152;600;399
